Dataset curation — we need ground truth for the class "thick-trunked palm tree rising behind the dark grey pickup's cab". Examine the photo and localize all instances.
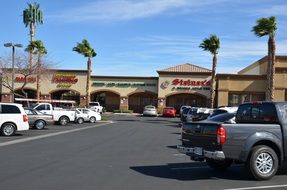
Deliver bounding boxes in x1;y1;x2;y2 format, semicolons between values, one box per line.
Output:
251;16;277;101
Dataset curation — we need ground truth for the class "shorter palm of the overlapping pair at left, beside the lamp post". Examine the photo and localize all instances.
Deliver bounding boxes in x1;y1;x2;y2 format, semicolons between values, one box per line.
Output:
26;40;47;100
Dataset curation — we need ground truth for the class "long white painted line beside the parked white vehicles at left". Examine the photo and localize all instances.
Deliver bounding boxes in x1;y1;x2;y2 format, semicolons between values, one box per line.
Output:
0;122;112;147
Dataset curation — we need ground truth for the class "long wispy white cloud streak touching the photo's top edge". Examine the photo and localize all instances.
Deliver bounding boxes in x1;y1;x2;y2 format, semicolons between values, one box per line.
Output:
48;0;230;22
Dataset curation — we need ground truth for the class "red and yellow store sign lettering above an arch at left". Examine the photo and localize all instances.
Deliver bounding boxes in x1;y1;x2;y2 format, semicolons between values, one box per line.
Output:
52;73;78;88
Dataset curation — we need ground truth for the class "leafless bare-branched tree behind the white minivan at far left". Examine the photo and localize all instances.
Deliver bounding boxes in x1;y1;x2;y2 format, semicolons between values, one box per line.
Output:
0;54;51;105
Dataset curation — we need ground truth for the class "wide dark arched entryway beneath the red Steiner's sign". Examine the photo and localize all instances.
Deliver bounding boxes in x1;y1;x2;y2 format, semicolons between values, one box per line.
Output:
166;93;208;113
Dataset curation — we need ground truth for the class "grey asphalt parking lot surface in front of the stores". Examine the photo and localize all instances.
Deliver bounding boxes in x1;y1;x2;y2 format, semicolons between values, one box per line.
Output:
0;115;287;190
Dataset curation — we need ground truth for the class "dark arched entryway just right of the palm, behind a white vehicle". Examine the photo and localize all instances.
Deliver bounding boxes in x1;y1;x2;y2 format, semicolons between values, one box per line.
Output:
91;91;120;112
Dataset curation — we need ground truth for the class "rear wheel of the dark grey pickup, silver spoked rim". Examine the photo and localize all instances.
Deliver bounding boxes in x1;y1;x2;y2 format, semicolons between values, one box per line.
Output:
246;145;279;180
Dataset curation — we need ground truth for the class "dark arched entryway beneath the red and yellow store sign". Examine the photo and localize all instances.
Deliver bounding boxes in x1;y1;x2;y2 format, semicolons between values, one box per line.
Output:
50;89;80;105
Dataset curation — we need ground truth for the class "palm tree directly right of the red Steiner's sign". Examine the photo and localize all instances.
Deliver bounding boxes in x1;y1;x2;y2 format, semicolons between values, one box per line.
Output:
199;35;220;108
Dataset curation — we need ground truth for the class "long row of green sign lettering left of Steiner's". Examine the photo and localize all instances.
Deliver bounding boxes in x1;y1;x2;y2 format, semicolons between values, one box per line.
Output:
93;82;156;88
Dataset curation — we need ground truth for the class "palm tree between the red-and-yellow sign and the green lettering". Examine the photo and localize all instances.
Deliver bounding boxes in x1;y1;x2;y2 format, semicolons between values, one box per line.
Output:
73;39;97;107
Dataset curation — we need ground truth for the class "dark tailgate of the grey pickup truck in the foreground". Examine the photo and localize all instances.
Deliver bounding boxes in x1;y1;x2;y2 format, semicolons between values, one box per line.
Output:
182;122;222;150
